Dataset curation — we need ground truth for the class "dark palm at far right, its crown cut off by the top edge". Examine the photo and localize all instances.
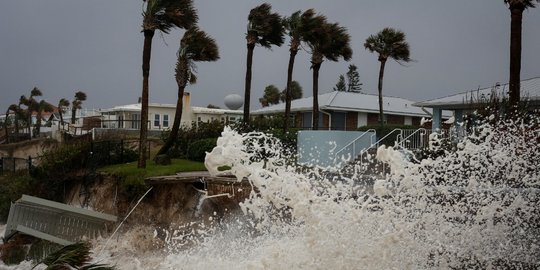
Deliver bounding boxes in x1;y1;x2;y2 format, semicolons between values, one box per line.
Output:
504;0;540;106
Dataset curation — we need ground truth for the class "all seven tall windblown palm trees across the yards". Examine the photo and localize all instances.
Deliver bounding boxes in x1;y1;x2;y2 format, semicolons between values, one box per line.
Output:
138;0;539;168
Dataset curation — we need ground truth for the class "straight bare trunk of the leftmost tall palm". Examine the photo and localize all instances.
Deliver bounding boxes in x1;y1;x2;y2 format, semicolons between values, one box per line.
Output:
137;29;155;168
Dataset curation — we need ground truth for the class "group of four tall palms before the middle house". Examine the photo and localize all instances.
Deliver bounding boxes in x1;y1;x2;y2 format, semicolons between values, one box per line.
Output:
240;3;411;131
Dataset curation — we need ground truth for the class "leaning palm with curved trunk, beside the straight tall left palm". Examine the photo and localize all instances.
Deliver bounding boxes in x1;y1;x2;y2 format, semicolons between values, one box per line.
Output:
157;27;219;155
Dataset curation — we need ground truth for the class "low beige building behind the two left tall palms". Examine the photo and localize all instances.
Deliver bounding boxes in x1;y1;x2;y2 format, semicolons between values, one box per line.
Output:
101;93;243;130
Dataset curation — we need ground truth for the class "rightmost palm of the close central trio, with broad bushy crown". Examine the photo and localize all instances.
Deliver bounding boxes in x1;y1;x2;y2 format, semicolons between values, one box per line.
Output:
305;20;352;130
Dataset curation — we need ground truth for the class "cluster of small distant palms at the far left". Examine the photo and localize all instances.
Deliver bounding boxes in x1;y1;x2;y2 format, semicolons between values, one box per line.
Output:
4;87;86;143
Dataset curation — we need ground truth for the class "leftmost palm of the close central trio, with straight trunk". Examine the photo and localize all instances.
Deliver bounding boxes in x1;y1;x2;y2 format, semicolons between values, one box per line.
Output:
244;3;285;124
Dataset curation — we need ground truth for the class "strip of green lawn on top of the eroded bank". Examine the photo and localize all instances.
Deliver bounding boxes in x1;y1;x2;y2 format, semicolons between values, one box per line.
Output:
98;159;206;196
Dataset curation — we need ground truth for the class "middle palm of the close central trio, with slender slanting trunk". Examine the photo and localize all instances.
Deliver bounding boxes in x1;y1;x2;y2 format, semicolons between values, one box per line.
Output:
283;9;321;132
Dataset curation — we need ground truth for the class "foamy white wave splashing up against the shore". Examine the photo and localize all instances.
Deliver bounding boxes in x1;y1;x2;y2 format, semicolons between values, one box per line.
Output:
4;116;540;269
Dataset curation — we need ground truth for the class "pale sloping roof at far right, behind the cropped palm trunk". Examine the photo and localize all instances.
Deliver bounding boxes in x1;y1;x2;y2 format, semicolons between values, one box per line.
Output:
413;77;540;109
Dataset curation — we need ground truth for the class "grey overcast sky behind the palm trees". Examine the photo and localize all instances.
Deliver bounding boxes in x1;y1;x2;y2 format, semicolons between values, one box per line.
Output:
0;0;540;113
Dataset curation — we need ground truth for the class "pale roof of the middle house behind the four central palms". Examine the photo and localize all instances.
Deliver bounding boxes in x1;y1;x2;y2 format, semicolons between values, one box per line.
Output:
253;91;430;117
